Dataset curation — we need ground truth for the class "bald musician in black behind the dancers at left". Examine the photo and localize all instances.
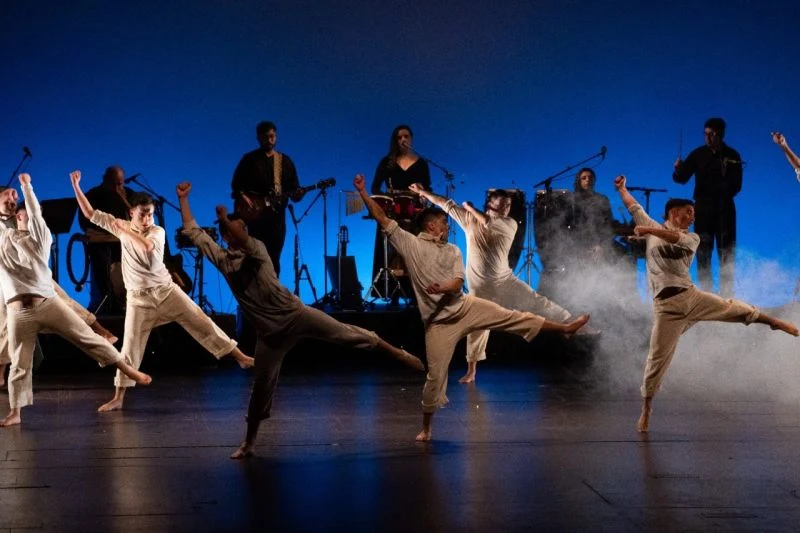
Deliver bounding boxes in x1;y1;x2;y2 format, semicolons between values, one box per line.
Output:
78;165;133;315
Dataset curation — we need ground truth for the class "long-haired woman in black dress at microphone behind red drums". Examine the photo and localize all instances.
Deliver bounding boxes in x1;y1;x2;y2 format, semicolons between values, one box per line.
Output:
370;124;431;298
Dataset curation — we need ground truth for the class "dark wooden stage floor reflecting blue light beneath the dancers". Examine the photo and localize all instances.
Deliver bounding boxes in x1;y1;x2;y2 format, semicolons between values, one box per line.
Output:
0;352;800;532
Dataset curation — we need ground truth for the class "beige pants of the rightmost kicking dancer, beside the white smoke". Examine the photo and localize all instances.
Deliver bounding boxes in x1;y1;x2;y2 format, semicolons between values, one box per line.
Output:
641;287;759;398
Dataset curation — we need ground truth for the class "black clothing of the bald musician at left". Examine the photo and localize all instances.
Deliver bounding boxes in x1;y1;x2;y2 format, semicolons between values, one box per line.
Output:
78;185;134;315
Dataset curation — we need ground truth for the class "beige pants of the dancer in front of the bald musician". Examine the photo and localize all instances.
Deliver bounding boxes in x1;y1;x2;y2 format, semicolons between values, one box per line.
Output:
114;283;236;387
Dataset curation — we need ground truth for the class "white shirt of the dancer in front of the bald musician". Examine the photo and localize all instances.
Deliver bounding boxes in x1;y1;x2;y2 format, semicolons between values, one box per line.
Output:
92;209;172;291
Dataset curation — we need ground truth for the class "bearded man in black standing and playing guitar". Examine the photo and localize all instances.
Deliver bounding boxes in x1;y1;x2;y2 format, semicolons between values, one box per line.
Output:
231;122;305;276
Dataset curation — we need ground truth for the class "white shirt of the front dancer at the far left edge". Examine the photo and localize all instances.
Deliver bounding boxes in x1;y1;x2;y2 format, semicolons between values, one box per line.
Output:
0;185;56;302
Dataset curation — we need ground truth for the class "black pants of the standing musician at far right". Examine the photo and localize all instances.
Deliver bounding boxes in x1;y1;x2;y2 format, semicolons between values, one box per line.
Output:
694;198;736;297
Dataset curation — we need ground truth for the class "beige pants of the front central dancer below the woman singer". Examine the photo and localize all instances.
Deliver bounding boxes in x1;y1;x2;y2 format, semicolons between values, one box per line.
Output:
422;294;545;413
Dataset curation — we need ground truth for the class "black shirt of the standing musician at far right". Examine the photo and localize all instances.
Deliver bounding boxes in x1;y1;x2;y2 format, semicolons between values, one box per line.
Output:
672;143;742;200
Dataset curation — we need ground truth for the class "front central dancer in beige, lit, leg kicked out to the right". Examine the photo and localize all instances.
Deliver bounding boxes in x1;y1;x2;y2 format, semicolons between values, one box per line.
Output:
353;174;589;441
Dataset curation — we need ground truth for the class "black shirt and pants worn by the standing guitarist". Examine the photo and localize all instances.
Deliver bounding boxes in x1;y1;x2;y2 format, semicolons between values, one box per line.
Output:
231;148;300;276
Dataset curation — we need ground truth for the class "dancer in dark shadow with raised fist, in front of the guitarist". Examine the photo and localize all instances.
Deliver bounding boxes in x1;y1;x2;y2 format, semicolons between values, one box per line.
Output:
177;182;425;459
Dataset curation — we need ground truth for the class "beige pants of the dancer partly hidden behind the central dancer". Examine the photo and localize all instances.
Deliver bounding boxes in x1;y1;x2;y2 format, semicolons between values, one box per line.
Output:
467;276;572;363
